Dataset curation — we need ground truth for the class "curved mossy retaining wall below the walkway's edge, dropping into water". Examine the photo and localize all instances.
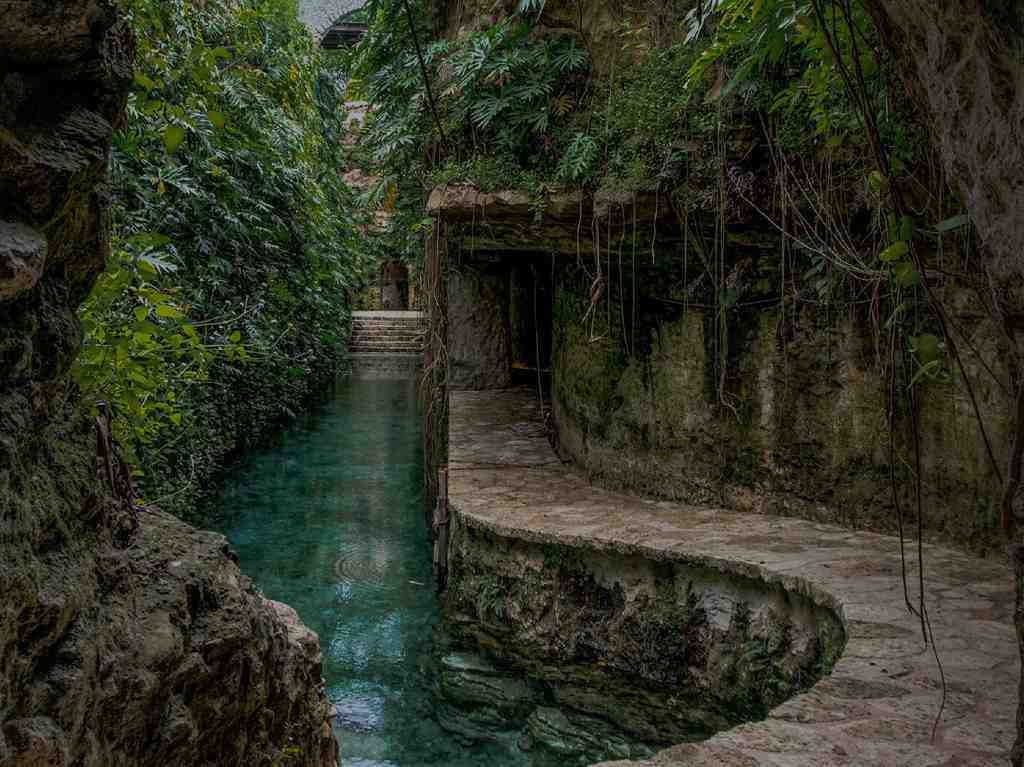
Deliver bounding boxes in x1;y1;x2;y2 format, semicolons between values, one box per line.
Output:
441;515;846;764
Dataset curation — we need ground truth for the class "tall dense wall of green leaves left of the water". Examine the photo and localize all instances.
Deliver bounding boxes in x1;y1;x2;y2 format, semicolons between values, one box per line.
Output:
78;0;368;510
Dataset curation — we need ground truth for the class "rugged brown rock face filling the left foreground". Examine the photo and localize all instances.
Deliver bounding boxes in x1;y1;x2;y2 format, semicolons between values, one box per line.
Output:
0;0;337;767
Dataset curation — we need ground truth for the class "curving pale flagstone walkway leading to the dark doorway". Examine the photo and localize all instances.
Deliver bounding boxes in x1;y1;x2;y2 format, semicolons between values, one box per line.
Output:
450;391;1019;767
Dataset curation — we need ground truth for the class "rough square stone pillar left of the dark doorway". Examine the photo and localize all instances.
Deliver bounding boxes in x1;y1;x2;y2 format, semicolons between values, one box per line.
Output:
447;263;512;389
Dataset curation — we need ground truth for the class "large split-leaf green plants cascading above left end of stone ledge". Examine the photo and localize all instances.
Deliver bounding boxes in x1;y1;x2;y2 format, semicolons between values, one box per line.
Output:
339;5;596;269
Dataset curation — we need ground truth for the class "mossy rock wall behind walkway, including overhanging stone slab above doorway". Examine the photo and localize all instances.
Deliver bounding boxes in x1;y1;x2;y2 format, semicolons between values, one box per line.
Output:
428;173;1013;554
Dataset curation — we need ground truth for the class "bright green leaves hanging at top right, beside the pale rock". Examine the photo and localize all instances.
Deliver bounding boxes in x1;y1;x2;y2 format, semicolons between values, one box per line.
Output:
685;0;927;164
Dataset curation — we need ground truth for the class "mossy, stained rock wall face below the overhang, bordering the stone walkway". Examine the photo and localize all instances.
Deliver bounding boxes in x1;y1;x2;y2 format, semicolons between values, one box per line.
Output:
552;255;1011;554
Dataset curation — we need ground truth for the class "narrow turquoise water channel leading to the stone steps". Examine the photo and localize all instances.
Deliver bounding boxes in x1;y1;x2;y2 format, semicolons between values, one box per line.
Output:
197;380;524;767
